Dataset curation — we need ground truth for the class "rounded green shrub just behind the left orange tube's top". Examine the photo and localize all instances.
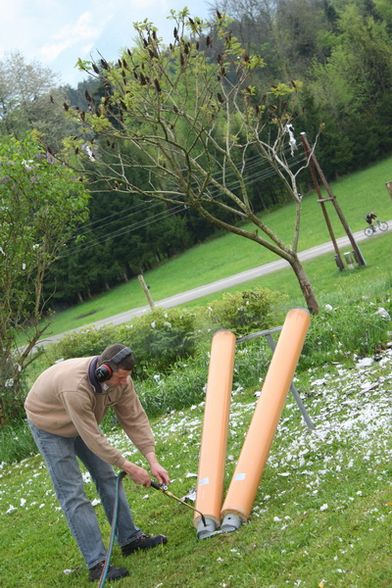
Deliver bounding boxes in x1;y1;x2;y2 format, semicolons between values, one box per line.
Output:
205;288;277;336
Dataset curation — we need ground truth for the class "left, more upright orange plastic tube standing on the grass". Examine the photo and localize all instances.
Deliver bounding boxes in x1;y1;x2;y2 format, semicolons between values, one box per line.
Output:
194;330;236;527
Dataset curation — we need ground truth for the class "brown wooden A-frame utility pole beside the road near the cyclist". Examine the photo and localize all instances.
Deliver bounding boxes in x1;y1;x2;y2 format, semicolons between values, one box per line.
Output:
301;132;366;270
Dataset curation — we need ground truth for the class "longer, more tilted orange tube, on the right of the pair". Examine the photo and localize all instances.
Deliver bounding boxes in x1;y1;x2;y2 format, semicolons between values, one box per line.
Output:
221;308;310;530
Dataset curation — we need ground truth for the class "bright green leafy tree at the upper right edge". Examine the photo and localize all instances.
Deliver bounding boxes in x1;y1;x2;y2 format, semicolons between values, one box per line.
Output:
305;4;392;176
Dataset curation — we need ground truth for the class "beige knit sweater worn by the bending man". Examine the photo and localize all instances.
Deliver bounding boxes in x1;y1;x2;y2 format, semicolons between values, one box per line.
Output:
25;357;154;468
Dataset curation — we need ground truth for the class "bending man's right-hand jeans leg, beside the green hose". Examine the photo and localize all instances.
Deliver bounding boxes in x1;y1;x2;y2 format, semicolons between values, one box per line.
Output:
75;437;141;546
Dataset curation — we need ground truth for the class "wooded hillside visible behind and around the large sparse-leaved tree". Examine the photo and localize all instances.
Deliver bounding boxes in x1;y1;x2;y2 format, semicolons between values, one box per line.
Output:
0;0;392;309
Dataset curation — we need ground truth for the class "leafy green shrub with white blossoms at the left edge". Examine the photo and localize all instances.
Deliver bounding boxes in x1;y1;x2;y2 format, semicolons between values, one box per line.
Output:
0;134;88;420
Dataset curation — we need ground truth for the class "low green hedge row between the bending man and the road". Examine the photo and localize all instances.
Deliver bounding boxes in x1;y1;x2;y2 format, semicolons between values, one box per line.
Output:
48;289;276;378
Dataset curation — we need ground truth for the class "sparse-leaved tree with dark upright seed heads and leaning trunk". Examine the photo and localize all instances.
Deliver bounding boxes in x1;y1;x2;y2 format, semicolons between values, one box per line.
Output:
64;9;318;312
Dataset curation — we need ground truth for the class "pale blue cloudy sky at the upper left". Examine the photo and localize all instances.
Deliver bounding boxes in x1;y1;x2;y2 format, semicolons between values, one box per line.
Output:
0;0;211;87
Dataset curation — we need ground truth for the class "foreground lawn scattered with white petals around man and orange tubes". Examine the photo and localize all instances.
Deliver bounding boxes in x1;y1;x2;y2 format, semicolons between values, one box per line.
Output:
0;349;392;588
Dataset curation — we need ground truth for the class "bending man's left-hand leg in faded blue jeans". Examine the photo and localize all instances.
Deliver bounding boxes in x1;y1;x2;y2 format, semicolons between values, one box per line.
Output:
29;422;106;568
